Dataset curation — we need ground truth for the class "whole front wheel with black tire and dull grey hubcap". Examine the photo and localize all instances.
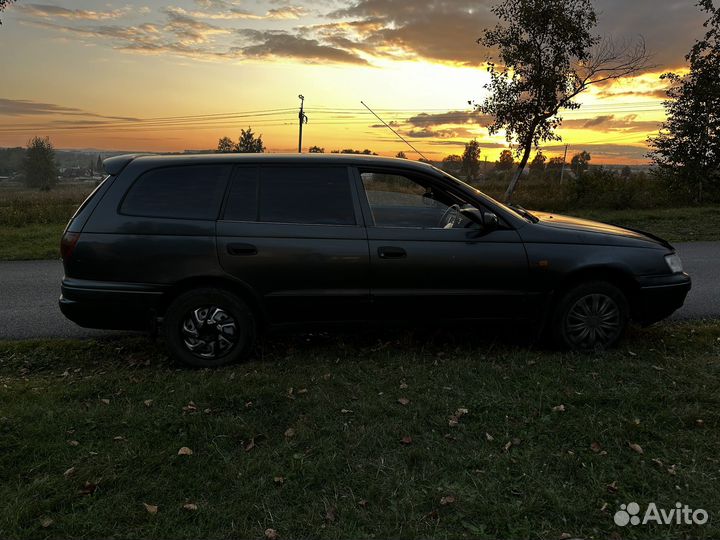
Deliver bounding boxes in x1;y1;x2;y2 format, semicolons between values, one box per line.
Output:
551;281;630;351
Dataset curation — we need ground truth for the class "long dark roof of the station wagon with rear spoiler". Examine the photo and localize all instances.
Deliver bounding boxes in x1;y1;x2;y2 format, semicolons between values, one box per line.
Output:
103;153;434;175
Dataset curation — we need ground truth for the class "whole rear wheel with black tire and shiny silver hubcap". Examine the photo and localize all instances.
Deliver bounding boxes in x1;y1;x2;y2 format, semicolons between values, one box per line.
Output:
162;288;256;368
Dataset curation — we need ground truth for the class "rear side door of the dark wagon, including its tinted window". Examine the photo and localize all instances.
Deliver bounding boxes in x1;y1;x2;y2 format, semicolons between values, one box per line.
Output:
217;163;369;322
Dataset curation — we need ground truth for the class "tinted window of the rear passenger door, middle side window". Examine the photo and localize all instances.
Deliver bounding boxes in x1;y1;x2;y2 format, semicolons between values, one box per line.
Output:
225;166;356;225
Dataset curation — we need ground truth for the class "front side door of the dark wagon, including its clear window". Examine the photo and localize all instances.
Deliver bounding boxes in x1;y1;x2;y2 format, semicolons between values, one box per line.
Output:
356;168;528;319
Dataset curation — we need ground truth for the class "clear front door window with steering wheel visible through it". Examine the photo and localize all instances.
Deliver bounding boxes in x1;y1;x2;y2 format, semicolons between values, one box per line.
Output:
360;172;470;229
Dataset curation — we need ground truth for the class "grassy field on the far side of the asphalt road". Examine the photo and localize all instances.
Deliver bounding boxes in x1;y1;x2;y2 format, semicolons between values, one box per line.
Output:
0;181;720;260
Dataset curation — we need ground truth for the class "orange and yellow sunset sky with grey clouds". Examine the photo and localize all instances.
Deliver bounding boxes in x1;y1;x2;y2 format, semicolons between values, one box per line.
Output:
0;0;703;163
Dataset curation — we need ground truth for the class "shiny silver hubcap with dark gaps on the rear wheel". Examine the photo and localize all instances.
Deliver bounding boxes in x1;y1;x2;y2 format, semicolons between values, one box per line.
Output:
181;306;238;359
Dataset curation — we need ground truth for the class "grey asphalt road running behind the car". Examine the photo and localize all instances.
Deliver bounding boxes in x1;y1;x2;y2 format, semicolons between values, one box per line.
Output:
0;242;720;339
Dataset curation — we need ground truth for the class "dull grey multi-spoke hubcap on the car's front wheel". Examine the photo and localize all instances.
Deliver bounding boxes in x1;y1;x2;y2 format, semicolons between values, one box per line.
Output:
565;293;621;349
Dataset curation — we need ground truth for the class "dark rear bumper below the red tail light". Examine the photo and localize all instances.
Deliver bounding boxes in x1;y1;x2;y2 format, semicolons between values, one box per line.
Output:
59;278;163;330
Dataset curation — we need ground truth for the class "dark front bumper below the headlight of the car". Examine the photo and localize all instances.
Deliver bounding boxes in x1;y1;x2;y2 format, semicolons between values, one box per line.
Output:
633;273;692;324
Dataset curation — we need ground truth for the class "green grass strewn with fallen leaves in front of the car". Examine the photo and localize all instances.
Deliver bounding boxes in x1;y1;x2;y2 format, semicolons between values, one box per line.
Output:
0;322;720;539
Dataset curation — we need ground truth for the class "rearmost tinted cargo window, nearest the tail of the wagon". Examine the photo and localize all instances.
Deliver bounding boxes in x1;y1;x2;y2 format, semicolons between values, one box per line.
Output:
120;165;231;220
